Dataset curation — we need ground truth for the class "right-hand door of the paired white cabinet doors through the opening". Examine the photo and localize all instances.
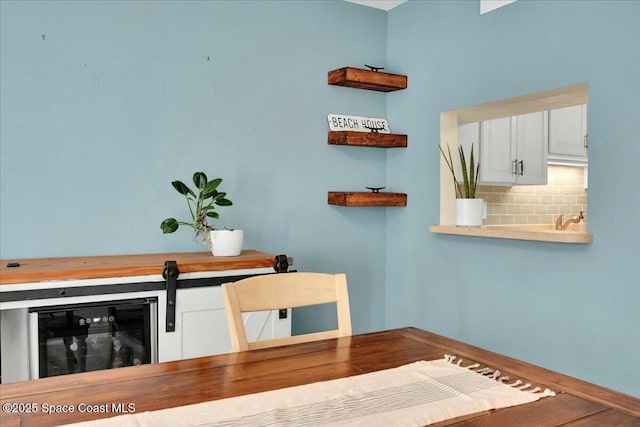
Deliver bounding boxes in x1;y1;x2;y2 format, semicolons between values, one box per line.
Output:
515;112;549;184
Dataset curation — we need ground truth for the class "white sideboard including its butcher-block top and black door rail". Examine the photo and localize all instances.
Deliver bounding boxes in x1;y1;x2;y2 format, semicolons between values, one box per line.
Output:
0;250;292;383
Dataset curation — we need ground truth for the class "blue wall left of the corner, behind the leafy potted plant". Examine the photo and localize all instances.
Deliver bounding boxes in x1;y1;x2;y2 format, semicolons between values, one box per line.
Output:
0;1;386;338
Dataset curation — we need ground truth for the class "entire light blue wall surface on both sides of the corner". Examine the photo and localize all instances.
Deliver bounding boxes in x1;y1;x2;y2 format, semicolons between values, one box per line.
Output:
0;0;640;396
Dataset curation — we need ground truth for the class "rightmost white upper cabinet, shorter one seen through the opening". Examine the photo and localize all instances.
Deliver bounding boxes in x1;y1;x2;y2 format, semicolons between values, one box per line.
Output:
549;104;588;164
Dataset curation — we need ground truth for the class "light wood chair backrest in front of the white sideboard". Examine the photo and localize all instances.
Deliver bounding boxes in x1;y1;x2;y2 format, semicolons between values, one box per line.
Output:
222;273;351;352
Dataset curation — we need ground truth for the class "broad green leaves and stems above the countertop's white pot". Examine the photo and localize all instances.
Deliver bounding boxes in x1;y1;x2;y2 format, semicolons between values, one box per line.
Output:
160;172;233;244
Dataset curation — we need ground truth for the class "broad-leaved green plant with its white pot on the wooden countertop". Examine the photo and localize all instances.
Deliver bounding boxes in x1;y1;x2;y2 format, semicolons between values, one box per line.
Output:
160;172;244;256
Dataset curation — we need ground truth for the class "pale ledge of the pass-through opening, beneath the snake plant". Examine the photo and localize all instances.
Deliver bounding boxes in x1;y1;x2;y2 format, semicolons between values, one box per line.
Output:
429;224;593;244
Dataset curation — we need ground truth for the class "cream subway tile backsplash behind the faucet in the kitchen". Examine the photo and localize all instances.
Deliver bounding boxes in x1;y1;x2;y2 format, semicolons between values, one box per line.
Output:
476;165;587;225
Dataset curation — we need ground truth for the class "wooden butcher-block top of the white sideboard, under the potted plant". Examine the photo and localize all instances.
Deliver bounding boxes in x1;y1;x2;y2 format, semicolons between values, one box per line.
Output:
0;250;275;285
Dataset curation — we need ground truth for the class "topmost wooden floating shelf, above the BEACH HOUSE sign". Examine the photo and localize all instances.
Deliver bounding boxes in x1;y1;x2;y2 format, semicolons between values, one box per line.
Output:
327;67;407;92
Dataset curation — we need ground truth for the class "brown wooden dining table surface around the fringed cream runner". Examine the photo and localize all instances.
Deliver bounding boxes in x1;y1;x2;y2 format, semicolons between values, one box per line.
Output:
0;327;640;427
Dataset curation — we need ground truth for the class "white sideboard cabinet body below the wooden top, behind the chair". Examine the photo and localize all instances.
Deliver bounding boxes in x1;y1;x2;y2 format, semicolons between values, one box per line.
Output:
0;268;291;383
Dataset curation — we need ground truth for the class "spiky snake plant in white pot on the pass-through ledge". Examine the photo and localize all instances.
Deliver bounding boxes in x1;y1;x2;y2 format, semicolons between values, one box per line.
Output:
438;144;484;226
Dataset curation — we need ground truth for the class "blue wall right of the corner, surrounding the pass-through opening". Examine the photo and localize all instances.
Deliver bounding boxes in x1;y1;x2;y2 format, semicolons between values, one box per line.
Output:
386;0;640;396
